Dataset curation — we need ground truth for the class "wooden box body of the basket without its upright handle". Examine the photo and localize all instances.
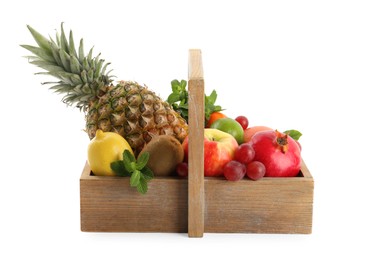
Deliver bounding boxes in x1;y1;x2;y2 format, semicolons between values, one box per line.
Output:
80;161;314;234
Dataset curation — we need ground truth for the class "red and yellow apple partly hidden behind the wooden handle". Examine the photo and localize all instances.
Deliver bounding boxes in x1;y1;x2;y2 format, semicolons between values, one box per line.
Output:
182;128;238;177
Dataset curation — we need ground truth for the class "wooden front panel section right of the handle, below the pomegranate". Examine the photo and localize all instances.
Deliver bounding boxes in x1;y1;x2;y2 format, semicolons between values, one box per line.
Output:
205;162;314;234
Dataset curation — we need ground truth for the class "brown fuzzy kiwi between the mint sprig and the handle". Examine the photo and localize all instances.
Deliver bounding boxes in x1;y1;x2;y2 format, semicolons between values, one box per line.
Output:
139;135;184;176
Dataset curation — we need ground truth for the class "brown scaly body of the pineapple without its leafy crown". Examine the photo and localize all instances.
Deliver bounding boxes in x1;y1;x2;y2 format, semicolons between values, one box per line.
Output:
86;81;188;155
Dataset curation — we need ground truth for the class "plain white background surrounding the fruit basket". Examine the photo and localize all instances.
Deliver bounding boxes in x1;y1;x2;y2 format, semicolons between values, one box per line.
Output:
0;0;375;259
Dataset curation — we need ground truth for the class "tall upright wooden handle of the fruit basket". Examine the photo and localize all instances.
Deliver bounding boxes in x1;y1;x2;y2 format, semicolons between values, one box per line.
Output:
188;49;205;237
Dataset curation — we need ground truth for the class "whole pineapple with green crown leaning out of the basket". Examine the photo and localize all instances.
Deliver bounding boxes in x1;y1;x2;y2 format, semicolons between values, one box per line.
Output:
21;24;188;154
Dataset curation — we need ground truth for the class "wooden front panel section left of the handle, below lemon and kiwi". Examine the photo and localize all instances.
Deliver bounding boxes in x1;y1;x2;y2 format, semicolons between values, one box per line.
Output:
80;165;188;233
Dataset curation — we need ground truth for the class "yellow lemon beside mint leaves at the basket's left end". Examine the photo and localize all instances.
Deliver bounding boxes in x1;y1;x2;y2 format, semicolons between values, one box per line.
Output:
87;130;133;176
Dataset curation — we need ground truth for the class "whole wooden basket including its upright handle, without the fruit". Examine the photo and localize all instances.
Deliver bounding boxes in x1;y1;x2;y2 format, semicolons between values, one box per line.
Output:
80;50;314;237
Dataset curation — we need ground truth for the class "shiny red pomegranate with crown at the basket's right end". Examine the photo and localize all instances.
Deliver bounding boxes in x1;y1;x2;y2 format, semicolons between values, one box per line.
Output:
250;130;301;177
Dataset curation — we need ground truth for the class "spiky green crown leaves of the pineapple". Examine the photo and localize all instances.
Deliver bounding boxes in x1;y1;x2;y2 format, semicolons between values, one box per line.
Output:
21;23;113;109
